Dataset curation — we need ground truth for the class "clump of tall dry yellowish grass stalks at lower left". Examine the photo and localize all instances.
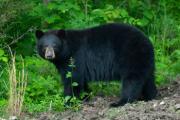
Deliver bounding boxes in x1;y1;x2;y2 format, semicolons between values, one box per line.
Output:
8;53;27;117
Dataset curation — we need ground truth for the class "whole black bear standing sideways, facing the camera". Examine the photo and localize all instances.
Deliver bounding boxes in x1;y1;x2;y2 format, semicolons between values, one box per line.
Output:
36;23;157;107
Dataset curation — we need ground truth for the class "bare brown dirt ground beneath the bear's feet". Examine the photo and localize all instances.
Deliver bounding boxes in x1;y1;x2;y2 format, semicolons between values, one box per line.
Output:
37;77;180;120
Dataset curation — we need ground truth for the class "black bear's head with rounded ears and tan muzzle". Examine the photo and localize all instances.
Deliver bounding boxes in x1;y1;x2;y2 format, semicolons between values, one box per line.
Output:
35;30;65;60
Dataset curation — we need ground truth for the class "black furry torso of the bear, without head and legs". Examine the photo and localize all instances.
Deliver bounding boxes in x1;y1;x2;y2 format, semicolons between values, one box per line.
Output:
67;24;153;80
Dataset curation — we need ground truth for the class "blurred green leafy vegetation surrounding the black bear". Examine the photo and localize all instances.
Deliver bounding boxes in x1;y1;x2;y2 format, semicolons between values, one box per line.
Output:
0;0;180;115
